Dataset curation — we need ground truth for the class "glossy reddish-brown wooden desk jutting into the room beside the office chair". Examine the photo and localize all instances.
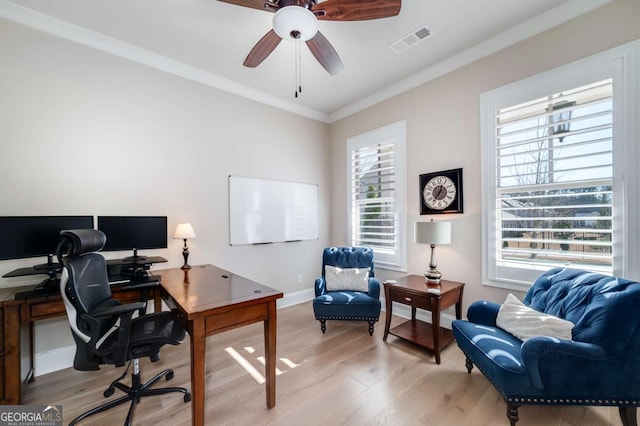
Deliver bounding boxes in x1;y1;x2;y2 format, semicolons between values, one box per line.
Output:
154;265;282;426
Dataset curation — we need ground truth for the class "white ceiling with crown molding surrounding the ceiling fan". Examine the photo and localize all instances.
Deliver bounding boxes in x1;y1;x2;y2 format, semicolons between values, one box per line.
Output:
0;0;610;121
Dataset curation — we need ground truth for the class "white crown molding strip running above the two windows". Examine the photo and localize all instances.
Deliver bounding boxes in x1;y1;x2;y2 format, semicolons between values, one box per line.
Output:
328;0;613;123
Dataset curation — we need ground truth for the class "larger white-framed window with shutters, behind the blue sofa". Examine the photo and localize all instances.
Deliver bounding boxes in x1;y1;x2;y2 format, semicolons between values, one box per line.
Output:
481;43;640;289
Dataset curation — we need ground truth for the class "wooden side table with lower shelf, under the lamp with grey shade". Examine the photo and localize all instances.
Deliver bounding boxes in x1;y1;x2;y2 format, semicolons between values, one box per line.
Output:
382;275;464;364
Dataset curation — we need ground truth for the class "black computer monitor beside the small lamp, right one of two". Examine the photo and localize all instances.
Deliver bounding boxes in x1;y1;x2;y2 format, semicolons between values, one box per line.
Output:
98;216;167;260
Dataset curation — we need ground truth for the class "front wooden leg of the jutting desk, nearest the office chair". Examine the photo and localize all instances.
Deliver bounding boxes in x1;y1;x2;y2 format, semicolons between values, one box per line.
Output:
189;318;207;426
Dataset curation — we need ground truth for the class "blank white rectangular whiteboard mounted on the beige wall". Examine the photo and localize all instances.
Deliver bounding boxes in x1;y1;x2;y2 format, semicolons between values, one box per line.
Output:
229;176;319;245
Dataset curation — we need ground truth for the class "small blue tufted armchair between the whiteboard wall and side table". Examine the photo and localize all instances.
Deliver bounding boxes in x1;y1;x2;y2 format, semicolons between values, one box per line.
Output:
313;247;381;335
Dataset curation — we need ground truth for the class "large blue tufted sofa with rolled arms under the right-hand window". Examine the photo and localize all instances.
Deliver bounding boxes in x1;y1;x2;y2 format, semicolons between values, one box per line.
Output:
452;268;640;426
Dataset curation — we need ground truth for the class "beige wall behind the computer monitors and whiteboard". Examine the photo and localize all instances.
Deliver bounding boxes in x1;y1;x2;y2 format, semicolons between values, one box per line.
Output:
0;20;330;370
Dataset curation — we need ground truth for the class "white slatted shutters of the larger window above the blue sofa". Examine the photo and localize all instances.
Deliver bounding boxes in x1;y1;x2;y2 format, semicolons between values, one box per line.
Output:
495;79;614;273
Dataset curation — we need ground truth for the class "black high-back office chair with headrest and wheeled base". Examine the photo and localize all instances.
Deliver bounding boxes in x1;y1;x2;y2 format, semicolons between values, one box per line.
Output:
57;229;191;425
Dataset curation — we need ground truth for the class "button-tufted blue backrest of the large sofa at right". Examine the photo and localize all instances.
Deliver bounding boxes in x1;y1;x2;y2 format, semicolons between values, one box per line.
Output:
524;268;640;357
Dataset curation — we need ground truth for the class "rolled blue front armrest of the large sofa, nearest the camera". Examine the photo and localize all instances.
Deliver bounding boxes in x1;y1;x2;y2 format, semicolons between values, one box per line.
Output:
521;336;604;389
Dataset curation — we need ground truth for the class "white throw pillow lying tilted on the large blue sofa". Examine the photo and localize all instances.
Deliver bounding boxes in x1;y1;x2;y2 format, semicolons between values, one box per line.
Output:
496;294;573;341
